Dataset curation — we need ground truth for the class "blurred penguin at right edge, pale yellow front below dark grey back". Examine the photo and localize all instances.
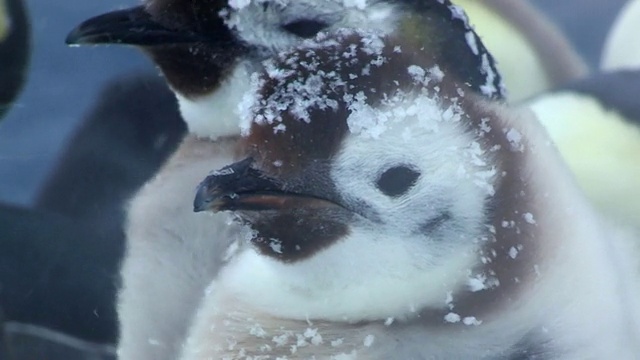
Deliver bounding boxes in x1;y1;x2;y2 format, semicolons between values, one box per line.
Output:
525;70;640;228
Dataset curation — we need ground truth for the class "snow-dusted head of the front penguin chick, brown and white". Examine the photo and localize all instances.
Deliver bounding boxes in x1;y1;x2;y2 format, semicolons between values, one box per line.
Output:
194;30;526;321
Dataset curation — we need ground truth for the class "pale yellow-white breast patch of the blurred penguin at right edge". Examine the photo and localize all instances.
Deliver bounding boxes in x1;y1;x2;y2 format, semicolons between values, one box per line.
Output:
531;93;640;228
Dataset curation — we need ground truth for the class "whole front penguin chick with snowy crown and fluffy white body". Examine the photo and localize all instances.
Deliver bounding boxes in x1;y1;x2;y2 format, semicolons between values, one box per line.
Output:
189;30;640;360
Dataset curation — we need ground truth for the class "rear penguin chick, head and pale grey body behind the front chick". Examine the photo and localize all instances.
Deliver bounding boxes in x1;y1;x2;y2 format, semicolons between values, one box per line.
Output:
92;0;503;360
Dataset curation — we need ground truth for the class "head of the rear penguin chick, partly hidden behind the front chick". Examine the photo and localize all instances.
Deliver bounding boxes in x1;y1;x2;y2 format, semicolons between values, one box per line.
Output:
67;0;503;138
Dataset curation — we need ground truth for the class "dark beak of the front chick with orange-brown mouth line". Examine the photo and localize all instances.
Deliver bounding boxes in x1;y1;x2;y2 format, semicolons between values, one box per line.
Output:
193;158;340;212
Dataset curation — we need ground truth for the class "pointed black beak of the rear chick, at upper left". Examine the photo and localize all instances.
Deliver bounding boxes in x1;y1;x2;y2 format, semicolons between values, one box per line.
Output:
66;6;206;46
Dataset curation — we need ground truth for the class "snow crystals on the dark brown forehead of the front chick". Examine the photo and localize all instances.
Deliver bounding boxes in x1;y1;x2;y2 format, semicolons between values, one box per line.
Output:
239;29;386;134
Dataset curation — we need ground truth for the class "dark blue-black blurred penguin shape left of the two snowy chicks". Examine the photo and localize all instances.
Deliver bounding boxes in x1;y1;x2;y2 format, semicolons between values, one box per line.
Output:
0;73;186;346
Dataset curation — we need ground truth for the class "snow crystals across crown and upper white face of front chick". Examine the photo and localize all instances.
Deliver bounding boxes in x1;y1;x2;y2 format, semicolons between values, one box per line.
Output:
240;24;495;146
